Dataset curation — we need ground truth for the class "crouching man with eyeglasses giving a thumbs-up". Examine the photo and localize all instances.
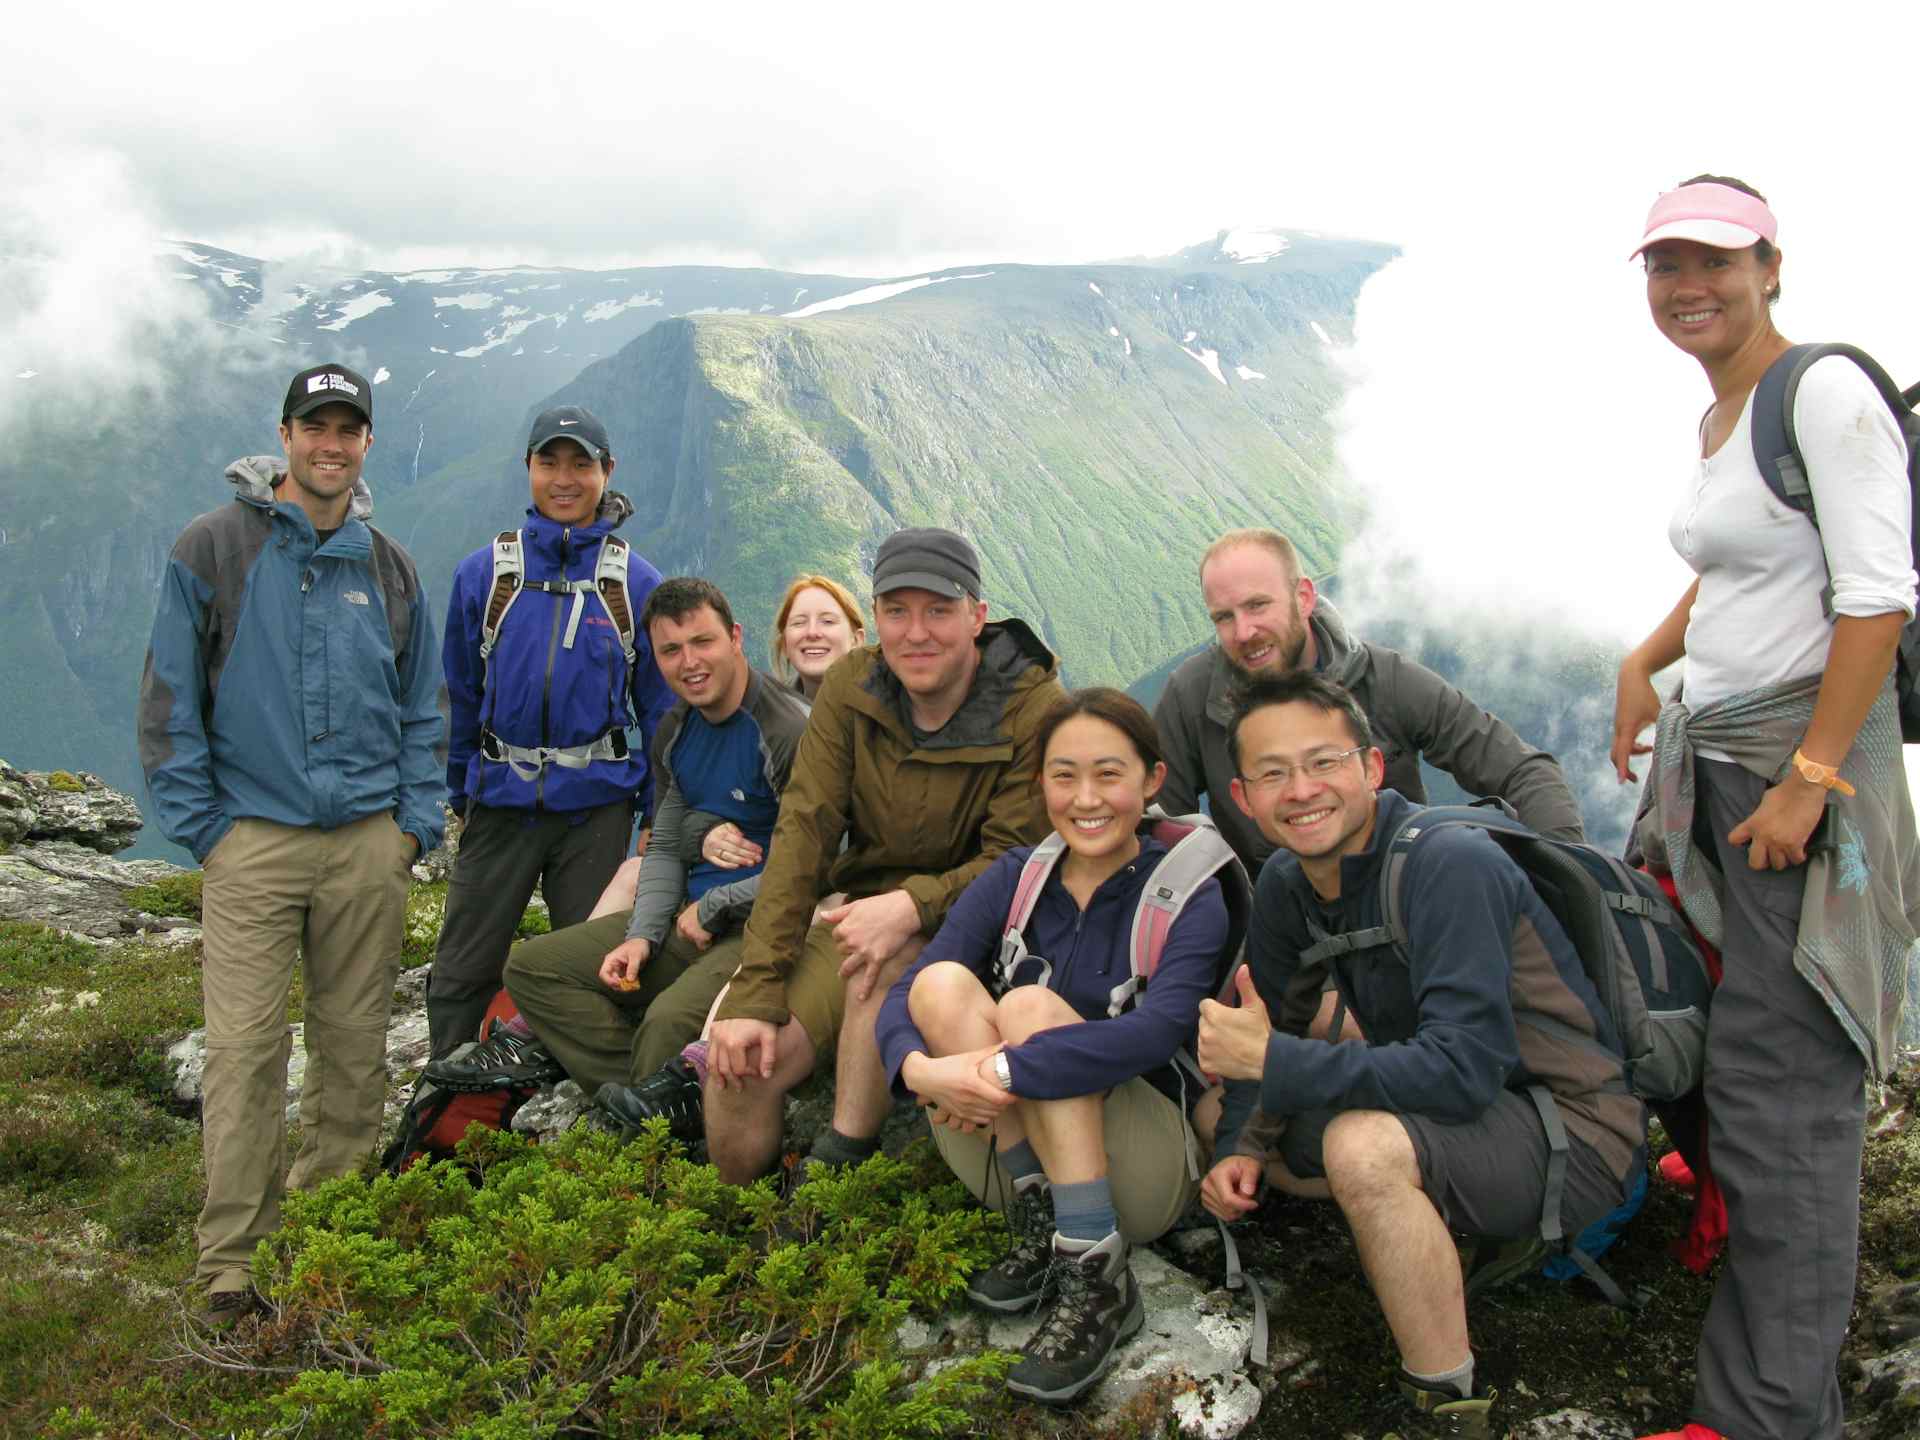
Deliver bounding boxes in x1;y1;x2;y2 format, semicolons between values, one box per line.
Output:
1200;670;1645;1436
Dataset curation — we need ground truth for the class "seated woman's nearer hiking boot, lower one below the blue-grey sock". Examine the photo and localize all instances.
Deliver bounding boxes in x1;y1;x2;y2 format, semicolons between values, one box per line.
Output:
1006;1231;1146;1405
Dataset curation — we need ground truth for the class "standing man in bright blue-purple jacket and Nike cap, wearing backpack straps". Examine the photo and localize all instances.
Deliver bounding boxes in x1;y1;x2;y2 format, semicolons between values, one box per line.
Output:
426;405;674;1058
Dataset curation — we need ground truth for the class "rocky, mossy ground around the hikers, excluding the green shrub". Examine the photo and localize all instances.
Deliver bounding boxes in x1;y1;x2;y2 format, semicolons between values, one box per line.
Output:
0;764;1920;1440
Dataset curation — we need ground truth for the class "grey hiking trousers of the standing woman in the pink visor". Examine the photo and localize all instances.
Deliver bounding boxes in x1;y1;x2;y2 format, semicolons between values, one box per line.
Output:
1692;760;1866;1440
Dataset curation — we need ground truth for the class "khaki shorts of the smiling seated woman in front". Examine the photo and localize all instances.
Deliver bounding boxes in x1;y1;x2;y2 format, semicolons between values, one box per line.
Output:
933;1075;1200;1244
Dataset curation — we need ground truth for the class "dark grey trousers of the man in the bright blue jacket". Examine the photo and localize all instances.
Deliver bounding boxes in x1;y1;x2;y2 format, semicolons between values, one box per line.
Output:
426;801;634;1058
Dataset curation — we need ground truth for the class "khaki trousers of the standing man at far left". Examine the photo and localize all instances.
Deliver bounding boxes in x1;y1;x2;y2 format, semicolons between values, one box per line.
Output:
196;814;413;1290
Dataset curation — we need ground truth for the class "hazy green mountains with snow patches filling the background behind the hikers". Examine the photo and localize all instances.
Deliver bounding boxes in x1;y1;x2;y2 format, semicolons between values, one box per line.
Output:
0;230;1620;852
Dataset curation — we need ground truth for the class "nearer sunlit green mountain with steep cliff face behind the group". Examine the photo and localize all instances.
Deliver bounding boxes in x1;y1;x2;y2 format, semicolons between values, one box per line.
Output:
389;248;1390;695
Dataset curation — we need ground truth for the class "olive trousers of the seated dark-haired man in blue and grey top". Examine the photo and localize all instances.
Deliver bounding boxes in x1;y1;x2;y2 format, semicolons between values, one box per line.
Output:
507;912;743;1096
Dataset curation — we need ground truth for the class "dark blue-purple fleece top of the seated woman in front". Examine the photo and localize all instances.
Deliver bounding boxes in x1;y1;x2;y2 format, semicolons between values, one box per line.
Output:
874;837;1227;1100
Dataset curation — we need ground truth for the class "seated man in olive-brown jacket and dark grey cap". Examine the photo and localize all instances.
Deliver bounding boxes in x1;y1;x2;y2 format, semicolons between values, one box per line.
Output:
705;530;1064;1185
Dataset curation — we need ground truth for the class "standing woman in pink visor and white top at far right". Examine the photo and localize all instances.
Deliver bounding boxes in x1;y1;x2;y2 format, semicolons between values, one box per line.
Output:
1613;175;1920;1440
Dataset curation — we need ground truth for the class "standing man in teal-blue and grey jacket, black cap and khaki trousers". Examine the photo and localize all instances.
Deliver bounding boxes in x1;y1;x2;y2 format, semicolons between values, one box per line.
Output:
138;365;445;1327
